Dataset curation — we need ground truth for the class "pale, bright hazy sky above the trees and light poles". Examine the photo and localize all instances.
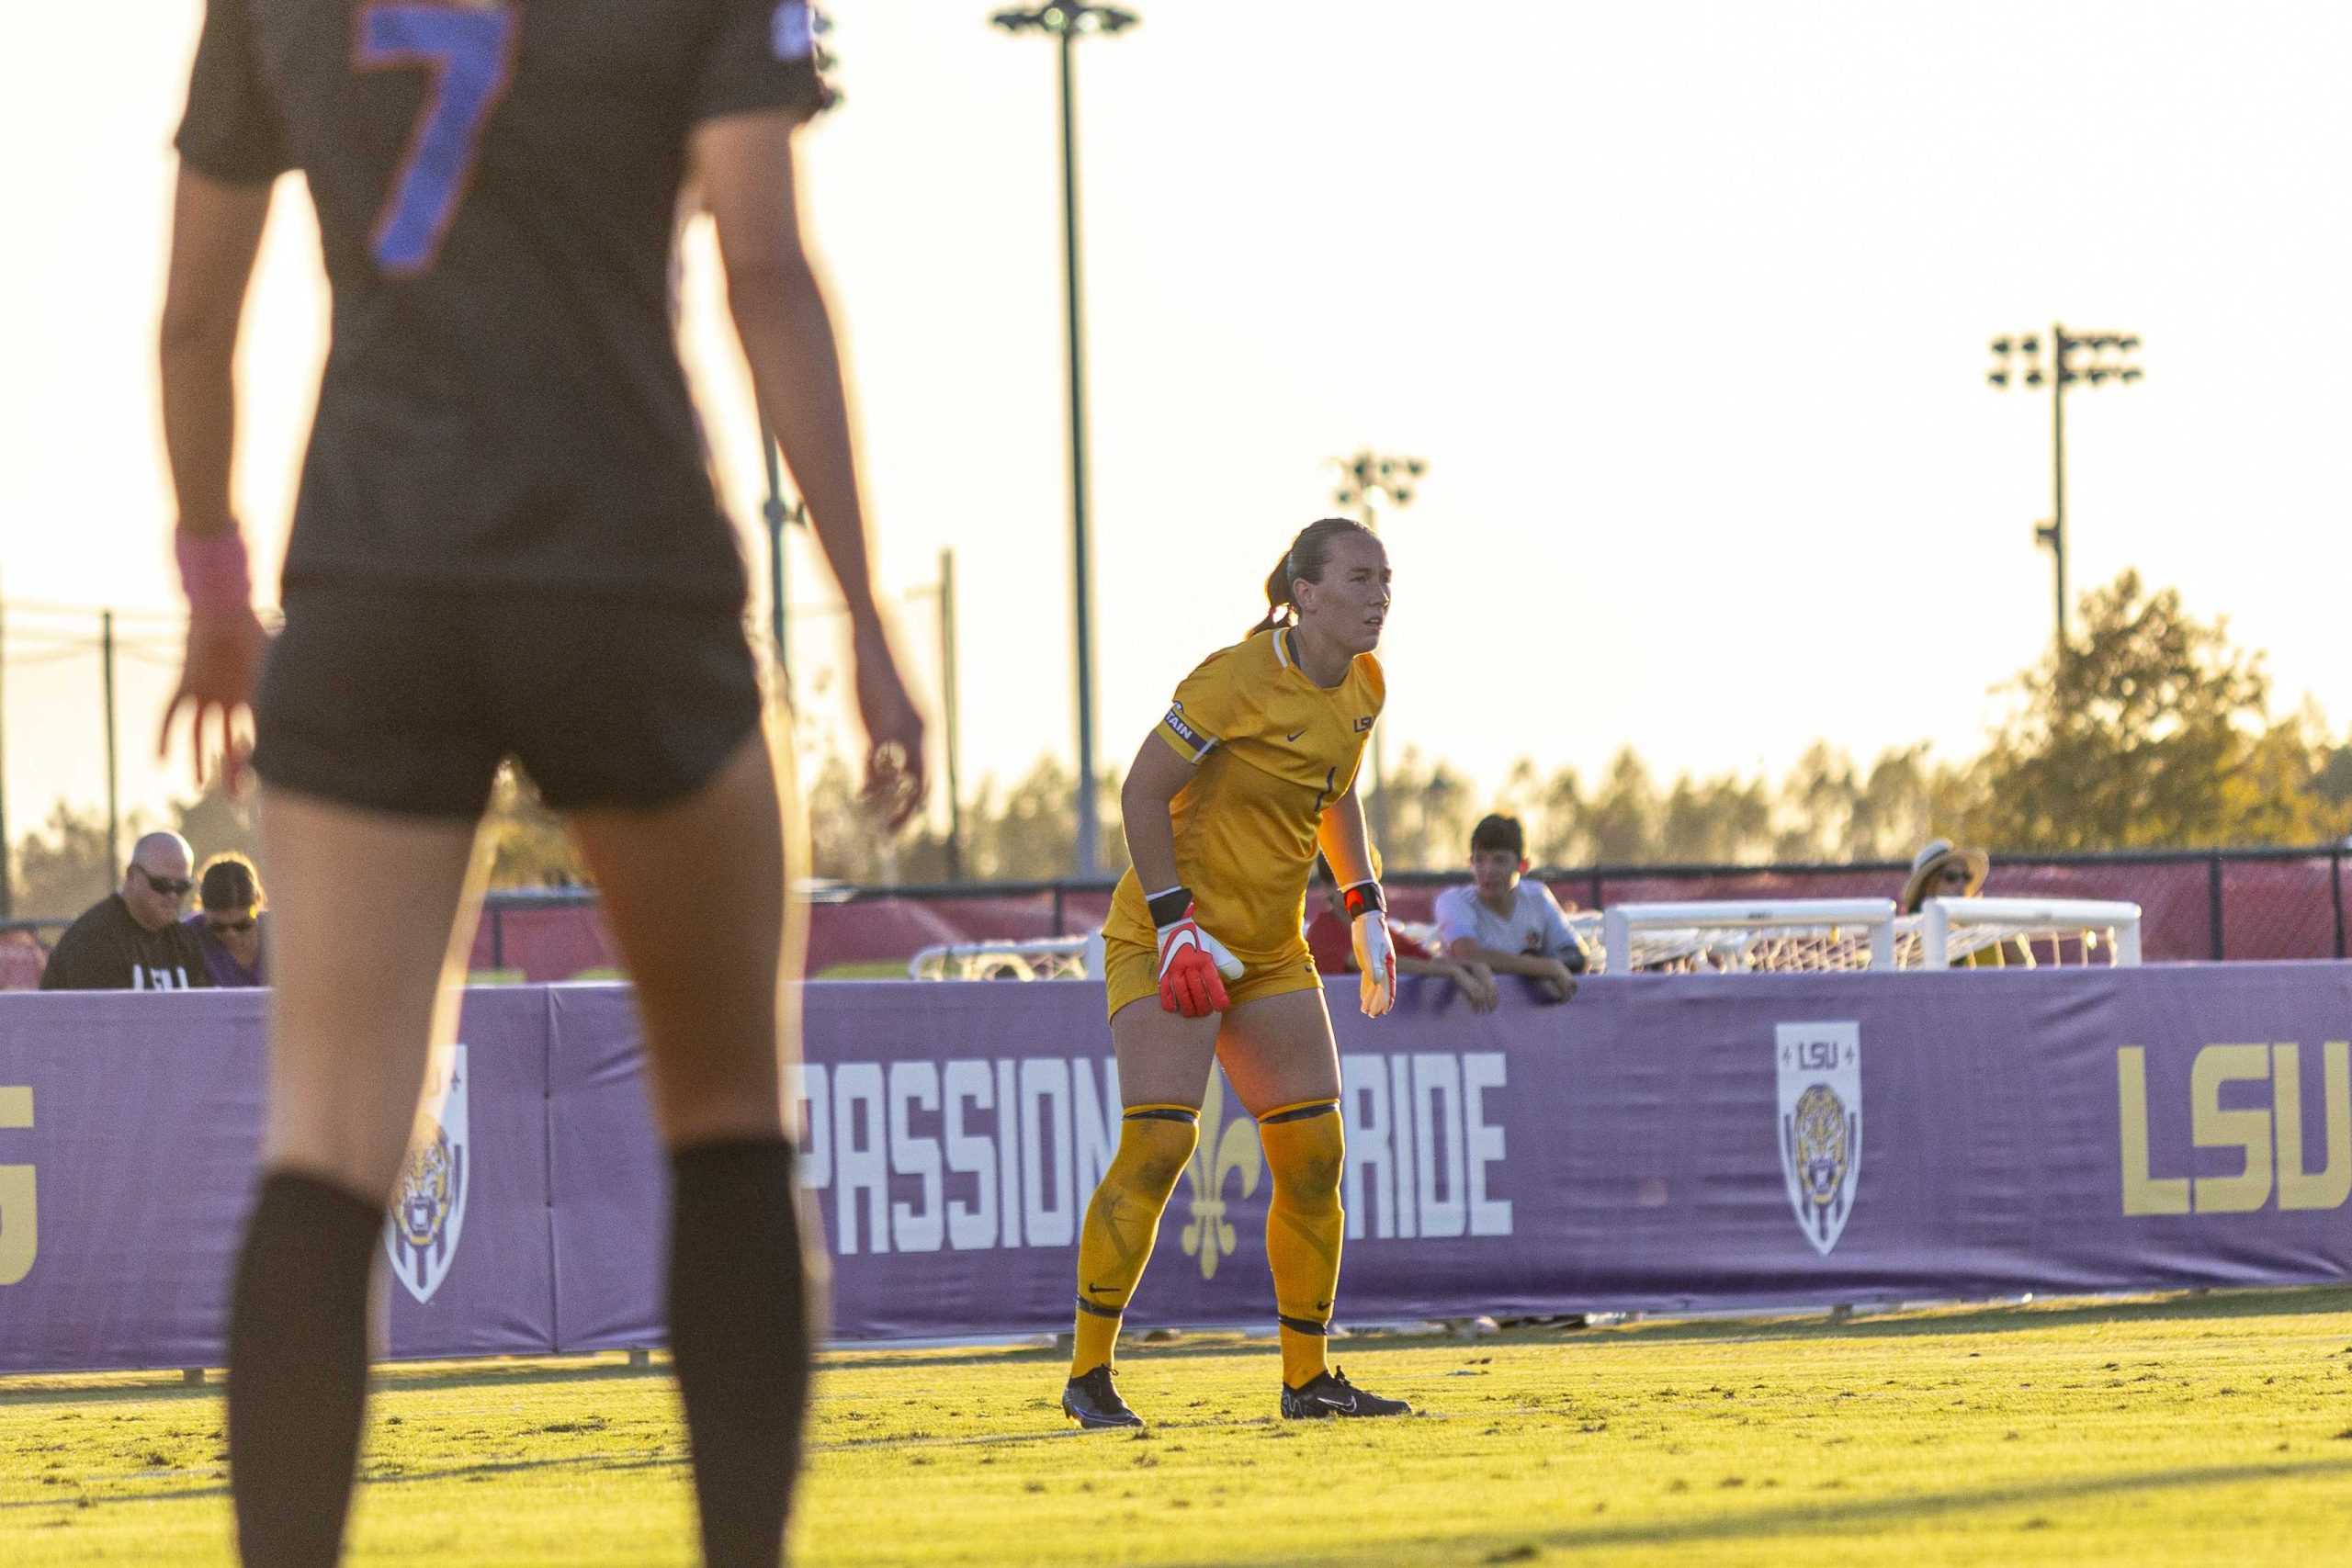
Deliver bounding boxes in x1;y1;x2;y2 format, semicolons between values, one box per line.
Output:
0;0;2352;860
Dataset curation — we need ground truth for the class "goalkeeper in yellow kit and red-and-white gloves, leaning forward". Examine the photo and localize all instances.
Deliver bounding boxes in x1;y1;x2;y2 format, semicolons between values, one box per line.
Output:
1061;517;1411;1427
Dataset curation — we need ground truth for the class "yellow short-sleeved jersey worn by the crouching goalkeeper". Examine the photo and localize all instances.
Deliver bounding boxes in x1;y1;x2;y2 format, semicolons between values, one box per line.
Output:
1103;627;1387;968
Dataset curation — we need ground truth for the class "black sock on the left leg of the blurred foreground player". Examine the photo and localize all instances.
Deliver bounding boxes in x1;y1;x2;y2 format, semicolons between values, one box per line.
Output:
228;1170;383;1568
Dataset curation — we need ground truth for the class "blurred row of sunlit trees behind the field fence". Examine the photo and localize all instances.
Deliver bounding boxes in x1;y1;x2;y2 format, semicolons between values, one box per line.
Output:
12;571;2352;917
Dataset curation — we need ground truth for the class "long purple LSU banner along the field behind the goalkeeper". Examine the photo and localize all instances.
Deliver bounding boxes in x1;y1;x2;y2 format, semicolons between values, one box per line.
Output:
0;964;2352;1371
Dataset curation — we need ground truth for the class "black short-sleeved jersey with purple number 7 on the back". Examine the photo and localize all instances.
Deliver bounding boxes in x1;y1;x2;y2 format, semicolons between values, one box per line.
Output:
179;0;823;604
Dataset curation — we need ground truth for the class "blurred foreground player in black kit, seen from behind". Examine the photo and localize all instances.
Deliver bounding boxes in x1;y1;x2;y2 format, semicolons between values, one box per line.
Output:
163;0;922;1563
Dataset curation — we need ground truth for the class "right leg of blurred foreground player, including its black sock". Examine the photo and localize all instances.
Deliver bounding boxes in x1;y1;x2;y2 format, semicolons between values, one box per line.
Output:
571;736;816;1568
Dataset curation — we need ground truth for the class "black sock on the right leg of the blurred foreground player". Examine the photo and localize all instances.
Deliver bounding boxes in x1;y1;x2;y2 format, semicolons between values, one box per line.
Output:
671;1138;809;1568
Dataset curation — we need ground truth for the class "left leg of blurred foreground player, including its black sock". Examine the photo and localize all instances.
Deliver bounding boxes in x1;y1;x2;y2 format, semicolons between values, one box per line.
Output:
228;787;482;1568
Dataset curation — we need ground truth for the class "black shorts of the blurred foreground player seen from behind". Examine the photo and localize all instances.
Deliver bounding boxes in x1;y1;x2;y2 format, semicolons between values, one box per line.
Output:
254;581;760;820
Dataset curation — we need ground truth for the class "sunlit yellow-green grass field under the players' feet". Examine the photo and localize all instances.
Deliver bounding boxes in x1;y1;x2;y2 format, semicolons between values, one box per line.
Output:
0;1288;2352;1568
